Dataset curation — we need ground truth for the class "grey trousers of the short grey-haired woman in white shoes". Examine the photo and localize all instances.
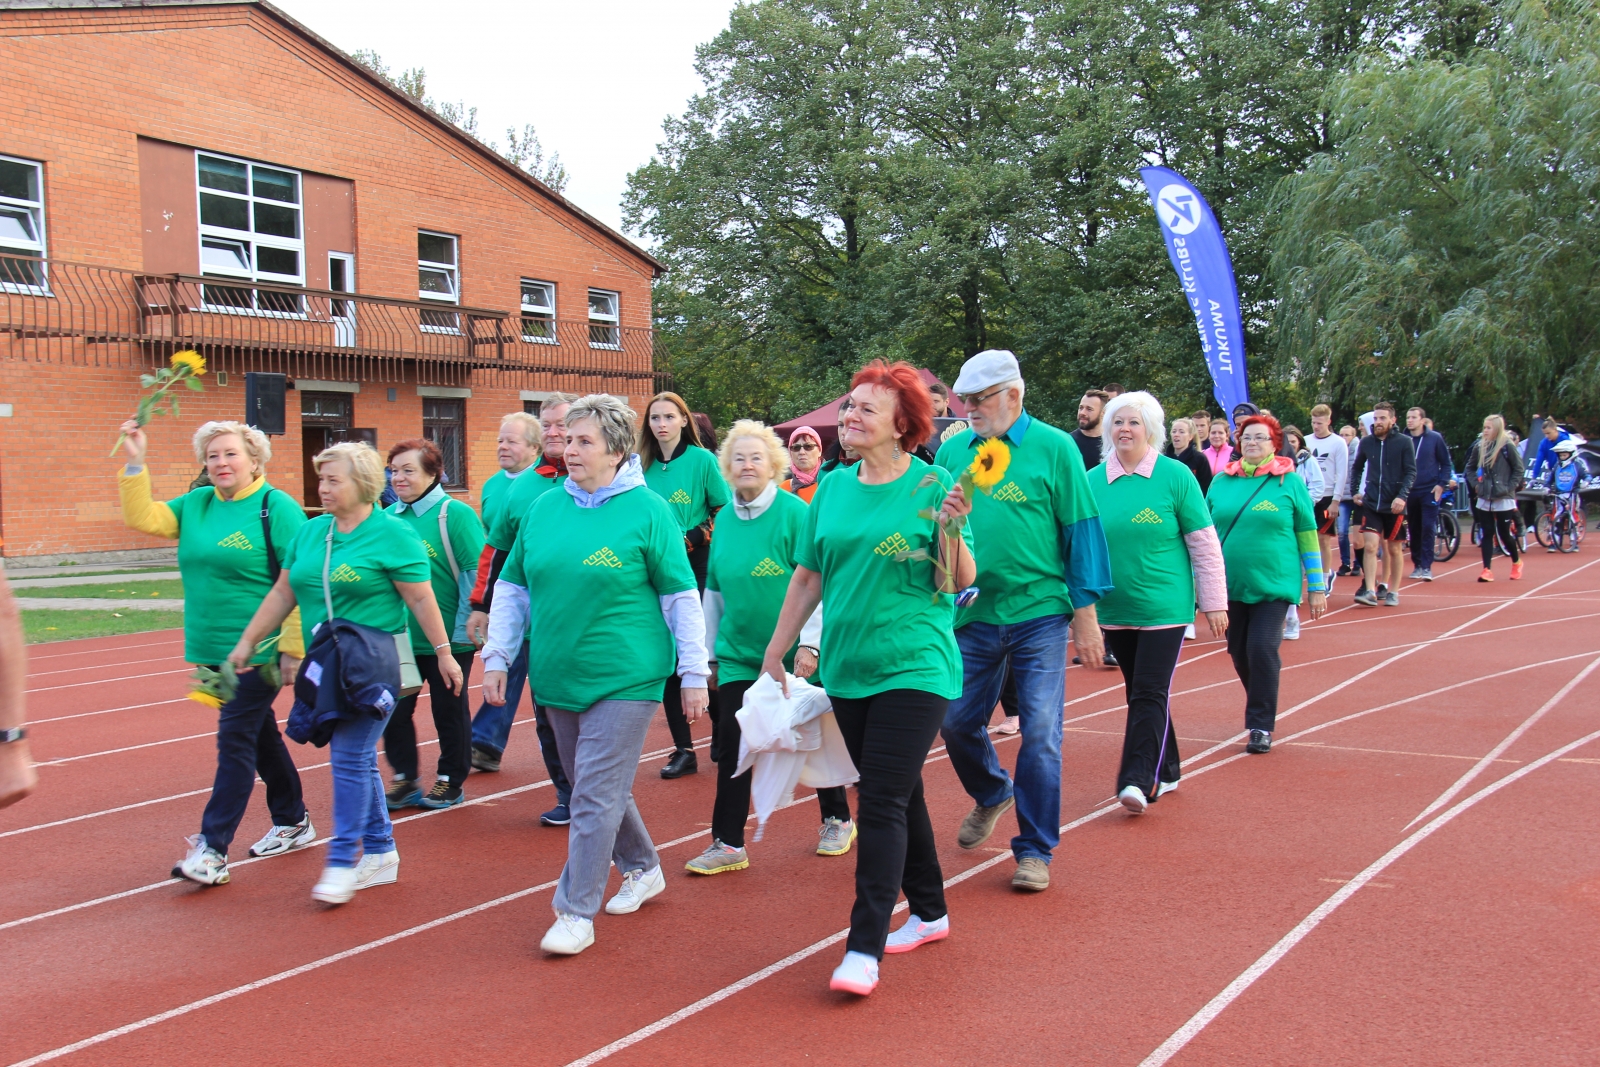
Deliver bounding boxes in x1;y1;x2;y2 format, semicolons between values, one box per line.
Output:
546;701;661;918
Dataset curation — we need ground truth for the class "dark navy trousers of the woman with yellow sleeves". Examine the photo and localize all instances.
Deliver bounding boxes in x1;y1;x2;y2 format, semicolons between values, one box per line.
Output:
200;670;306;856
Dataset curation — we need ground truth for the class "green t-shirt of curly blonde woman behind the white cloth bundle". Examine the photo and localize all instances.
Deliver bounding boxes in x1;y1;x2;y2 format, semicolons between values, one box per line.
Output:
706;491;806;681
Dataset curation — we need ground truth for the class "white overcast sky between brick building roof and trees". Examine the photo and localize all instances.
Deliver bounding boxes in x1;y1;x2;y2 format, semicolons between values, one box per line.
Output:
274;0;734;238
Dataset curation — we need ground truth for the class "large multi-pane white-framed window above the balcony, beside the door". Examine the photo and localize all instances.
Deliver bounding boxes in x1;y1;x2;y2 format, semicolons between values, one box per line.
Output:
195;152;306;315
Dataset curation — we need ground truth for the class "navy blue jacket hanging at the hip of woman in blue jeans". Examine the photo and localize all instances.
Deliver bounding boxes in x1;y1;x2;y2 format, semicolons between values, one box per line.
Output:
283;619;400;749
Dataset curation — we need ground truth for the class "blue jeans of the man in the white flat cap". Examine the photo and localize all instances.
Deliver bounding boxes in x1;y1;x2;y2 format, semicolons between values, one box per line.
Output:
941;614;1067;864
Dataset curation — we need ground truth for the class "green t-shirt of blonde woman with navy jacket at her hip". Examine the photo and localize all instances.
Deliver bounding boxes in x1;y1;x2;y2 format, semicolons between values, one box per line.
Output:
283;507;429;648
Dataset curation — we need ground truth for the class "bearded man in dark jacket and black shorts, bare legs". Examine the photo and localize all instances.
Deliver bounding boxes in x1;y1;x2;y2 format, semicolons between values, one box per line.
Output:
1350;400;1416;608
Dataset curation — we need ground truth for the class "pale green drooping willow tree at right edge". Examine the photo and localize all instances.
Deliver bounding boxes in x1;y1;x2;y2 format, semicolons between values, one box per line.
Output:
1275;0;1600;440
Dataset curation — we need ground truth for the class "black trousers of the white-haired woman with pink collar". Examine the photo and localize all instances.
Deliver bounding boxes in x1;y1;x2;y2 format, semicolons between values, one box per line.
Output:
1106;625;1184;803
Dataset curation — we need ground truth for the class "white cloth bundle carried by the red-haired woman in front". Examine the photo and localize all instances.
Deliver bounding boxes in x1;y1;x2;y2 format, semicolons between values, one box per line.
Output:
734;675;861;841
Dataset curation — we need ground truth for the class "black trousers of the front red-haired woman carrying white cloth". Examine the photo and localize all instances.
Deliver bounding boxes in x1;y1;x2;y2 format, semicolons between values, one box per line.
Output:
834;689;950;960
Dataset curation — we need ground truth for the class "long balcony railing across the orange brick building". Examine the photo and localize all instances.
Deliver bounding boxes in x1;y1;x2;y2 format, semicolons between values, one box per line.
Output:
0;254;664;394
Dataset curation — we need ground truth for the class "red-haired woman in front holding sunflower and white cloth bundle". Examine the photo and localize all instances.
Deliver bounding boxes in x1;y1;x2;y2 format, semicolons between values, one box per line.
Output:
762;360;978;995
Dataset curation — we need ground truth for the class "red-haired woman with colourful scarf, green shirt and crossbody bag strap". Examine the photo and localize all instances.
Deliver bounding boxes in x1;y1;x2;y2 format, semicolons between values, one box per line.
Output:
1206;414;1328;753
